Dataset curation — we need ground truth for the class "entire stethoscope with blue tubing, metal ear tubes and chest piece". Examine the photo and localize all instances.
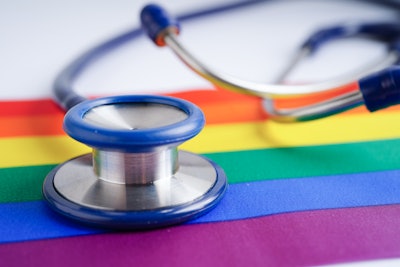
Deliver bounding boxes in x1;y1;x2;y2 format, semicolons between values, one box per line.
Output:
43;1;400;229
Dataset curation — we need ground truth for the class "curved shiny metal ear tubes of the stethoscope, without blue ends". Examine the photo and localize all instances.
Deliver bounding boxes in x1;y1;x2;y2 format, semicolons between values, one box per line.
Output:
164;33;399;122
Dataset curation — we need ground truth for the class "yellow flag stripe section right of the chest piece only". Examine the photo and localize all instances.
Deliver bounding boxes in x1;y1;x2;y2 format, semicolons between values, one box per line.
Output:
186;112;400;153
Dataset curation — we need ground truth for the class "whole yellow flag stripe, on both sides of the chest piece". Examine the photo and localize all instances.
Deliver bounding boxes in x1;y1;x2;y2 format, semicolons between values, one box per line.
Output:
0;112;400;167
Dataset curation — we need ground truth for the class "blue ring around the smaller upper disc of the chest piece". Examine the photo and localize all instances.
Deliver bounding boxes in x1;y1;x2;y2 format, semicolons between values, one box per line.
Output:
64;95;205;152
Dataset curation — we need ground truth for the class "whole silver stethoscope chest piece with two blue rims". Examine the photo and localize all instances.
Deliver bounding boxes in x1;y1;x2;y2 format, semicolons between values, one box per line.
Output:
43;95;227;229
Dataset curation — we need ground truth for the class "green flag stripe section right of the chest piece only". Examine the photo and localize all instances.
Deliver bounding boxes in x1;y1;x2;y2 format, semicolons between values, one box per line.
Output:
205;139;400;183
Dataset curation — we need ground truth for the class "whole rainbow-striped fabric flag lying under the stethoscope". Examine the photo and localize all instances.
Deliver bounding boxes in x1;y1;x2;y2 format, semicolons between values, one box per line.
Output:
0;90;400;266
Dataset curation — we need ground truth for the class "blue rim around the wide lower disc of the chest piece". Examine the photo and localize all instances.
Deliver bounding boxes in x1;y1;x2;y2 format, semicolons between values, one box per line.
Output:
43;155;228;230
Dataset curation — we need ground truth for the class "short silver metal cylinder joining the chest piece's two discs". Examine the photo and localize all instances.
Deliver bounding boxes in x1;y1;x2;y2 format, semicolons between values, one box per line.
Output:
93;147;179;185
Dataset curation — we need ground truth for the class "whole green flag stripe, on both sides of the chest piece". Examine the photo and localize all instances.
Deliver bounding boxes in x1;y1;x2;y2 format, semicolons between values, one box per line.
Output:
0;139;400;202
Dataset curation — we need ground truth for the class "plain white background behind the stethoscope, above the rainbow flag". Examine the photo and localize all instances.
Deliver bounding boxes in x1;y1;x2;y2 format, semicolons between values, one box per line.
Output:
0;0;394;100
